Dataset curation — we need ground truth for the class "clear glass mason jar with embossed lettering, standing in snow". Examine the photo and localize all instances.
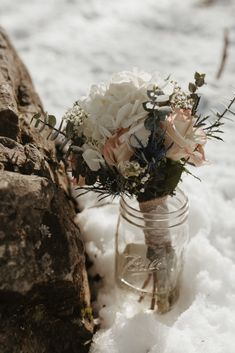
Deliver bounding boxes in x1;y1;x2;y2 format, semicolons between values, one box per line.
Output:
115;188;188;313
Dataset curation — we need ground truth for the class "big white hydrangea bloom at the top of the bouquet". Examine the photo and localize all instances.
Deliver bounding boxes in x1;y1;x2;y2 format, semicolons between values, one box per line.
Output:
79;70;162;146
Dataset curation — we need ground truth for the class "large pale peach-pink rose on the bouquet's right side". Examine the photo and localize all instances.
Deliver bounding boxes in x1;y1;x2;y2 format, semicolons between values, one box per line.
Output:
163;109;207;167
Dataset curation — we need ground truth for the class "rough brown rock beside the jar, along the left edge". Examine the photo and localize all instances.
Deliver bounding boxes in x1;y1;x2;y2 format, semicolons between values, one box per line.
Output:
0;29;93;353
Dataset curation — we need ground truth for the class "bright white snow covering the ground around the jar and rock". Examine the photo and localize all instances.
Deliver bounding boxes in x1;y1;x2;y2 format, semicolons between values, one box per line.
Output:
0;0;235;353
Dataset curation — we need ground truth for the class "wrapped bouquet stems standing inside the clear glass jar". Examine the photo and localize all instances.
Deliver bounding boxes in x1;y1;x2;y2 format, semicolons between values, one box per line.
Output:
139;196;177;313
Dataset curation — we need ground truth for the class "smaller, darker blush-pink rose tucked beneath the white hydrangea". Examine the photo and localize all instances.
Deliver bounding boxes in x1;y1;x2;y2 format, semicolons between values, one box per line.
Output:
103;128;133;166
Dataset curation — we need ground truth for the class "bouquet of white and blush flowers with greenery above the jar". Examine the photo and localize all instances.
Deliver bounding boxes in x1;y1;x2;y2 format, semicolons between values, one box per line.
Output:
32;70;234;310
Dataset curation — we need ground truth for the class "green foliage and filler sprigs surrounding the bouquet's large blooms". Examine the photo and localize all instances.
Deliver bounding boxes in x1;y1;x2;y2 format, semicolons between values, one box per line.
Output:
32;72;235;202
